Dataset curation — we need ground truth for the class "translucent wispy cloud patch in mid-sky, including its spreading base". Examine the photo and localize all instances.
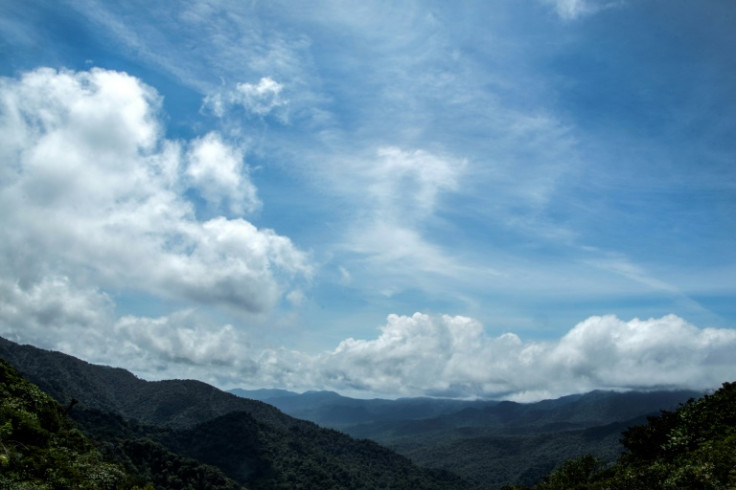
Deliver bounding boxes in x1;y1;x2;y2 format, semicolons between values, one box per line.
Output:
320;146;488;297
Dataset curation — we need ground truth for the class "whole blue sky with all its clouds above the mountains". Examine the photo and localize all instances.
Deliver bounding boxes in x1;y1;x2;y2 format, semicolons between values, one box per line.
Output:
0;0;736;401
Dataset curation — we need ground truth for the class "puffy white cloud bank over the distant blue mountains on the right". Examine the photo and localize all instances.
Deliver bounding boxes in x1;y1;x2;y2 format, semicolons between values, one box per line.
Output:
310;313;736;400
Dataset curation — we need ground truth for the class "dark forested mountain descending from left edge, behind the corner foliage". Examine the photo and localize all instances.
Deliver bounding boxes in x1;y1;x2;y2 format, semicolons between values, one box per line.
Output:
0;339;473;489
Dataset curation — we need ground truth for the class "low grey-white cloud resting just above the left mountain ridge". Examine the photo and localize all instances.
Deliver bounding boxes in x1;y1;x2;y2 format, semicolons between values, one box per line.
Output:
0;277;254;382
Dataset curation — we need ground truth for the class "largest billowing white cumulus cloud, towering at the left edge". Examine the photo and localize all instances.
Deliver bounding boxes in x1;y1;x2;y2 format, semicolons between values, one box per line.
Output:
0;68;311;313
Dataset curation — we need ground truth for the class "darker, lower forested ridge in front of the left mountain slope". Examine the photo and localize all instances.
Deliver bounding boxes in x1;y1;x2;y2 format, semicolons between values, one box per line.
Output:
75;410;472;490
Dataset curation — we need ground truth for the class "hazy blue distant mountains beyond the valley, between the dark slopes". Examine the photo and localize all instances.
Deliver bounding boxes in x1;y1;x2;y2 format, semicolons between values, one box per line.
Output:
236;384;702;489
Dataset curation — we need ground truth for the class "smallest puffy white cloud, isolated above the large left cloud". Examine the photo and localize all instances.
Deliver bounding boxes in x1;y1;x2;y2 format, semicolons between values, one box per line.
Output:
204;77;288;119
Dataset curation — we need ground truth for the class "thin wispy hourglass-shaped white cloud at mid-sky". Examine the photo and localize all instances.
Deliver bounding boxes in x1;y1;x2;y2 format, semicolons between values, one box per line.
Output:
332;147;466;280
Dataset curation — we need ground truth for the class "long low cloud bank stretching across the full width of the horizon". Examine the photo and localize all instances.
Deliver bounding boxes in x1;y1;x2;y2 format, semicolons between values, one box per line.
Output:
0;277;736;401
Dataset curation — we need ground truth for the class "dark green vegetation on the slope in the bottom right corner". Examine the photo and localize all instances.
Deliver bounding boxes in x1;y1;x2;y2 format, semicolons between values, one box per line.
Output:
509;383;736;490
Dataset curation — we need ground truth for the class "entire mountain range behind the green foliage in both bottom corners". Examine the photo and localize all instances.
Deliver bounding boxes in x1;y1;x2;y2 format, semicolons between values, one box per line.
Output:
0;338;699;489
